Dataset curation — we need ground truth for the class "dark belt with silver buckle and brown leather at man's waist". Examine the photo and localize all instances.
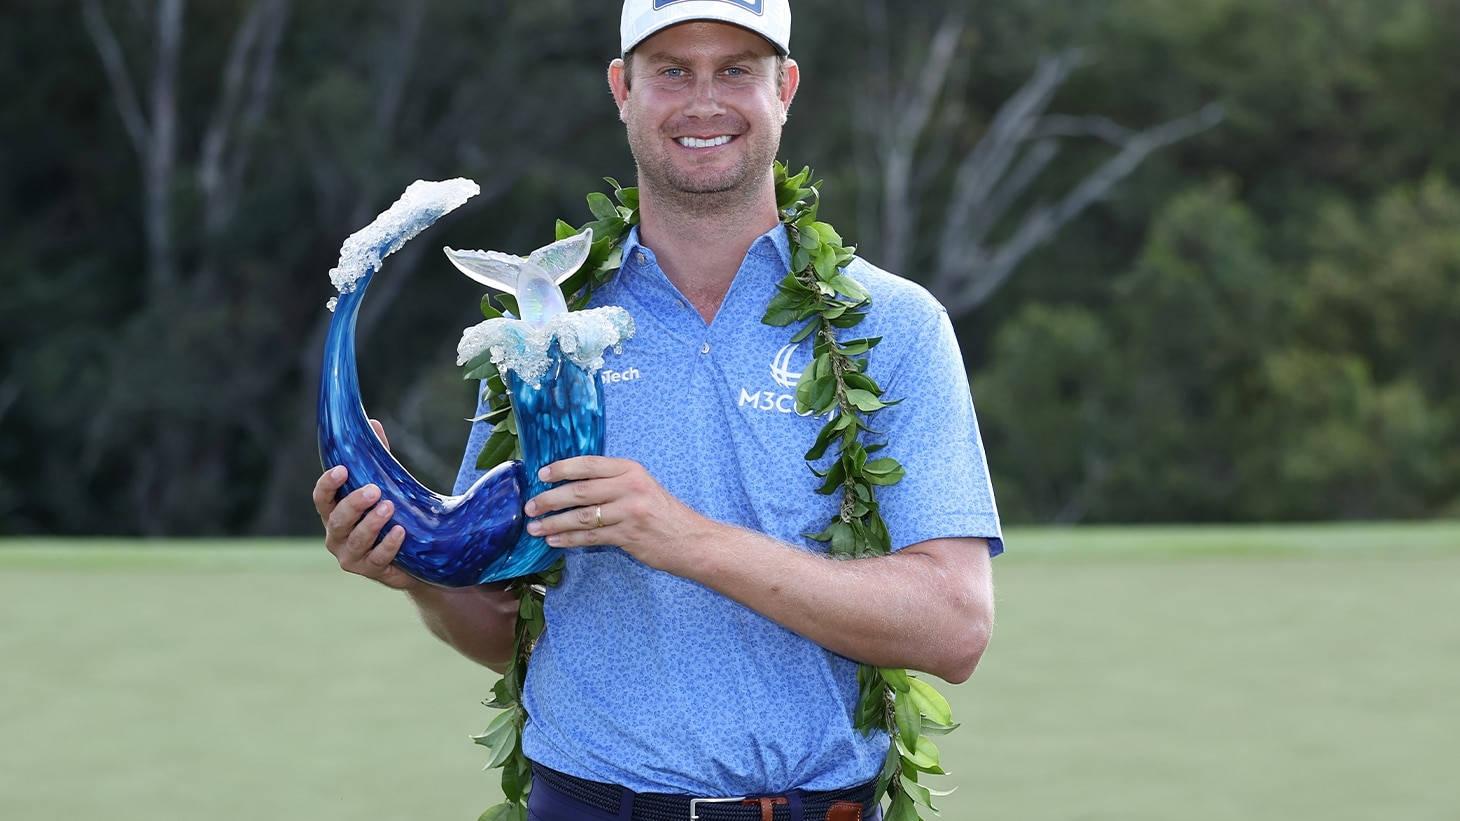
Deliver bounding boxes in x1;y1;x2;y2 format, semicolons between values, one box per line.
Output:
533;764;876;821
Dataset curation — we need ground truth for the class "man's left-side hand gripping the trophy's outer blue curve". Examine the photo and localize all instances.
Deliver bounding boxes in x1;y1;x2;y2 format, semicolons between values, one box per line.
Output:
314;419;422;590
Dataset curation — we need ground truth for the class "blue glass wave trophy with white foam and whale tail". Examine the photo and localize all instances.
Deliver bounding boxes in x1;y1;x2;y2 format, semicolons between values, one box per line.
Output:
318;180;632;587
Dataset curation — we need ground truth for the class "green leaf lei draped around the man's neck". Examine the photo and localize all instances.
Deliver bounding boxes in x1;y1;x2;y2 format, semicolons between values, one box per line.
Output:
466;162;958;821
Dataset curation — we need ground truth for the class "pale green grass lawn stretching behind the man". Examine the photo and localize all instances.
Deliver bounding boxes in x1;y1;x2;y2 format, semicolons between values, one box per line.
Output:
0;523;1460;821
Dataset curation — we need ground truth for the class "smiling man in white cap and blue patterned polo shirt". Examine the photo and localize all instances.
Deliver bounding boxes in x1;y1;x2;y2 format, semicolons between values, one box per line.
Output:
314;0;1003;820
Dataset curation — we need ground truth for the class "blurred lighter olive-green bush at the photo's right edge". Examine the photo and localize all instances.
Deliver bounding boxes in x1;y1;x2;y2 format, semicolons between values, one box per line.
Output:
1267;175;1460;517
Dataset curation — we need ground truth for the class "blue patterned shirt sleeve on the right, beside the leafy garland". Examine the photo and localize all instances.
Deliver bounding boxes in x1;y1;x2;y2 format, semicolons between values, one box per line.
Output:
869;310;1003;555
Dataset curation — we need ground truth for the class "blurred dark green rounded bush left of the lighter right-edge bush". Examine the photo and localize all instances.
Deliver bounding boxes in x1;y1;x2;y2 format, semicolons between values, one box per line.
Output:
975;181;1288;522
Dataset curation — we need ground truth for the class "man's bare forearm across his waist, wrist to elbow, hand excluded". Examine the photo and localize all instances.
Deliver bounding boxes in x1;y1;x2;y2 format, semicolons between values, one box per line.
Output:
680;522;993;684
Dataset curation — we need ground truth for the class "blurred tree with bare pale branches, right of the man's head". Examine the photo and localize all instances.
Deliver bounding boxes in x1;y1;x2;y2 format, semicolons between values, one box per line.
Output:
856;0;1222;318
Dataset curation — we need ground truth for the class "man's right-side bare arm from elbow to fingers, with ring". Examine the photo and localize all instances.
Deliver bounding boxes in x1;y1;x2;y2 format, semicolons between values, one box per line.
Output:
527;456;993;684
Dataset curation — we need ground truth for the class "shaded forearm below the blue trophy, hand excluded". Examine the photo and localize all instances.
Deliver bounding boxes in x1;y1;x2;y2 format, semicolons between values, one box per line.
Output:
406;583;517;672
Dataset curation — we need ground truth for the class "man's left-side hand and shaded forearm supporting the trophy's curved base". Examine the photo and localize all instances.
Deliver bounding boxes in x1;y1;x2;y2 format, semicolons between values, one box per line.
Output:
314;419;517;672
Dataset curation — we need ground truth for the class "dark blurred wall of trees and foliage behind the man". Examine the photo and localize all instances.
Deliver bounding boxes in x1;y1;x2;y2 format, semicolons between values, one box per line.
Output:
0;0;1460;535
